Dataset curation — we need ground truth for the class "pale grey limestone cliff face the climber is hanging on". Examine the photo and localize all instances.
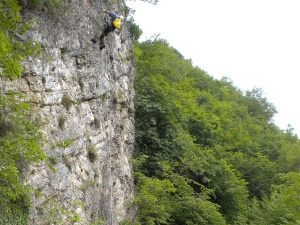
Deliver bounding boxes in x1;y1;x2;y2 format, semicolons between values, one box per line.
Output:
0;0;134;225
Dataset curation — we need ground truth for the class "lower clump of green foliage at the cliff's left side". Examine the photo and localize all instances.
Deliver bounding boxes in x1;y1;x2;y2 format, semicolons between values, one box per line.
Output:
0;92;45;224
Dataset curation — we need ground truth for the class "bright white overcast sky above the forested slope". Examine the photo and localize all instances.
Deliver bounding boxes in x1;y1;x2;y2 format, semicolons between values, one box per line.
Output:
126;0;300;137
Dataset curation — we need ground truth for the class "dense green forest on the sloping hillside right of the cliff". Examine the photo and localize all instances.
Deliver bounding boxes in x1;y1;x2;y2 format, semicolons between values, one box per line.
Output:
129;39;300;225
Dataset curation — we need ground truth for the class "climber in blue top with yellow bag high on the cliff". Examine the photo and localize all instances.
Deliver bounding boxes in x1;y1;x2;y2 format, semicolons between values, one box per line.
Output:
96;10;124;50
